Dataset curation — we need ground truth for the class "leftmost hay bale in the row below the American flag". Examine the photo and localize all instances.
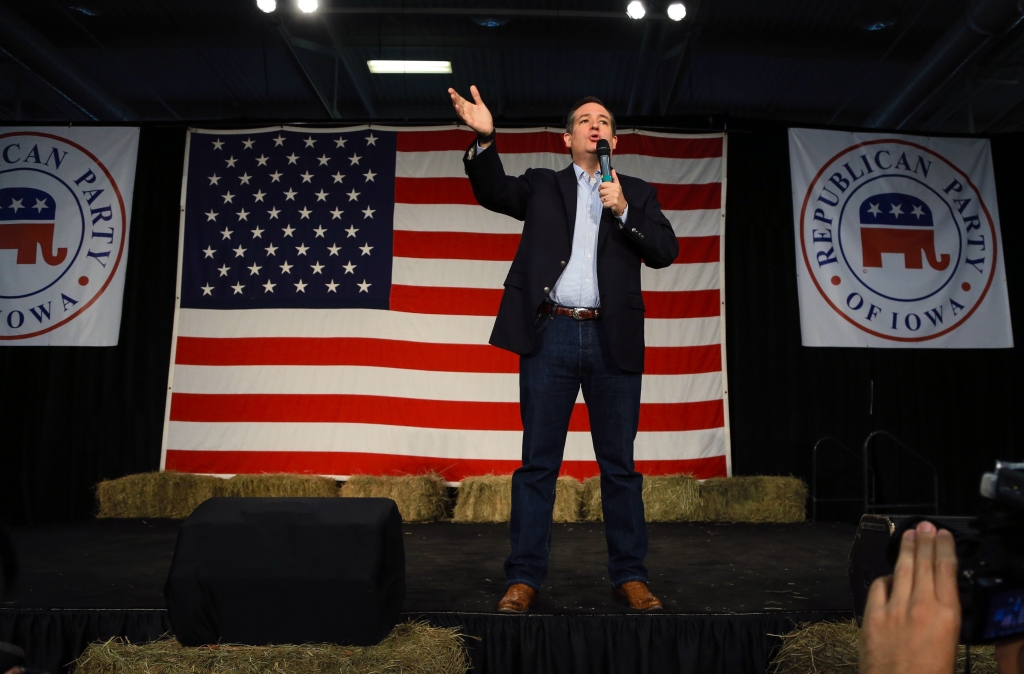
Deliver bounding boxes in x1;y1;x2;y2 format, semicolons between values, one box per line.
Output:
96;470;226;519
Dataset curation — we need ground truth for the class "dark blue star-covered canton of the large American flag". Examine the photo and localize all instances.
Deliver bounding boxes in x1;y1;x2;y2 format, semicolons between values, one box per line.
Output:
180;129;396;309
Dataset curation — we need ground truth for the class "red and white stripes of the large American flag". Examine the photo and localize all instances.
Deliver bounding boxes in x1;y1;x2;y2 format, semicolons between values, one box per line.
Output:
163;128;730;481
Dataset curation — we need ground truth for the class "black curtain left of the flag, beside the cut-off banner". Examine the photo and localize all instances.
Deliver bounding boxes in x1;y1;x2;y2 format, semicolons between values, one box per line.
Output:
0;127;185;524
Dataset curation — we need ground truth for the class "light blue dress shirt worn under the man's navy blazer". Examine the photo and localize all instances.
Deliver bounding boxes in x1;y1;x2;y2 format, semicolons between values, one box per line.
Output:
476;143;630;308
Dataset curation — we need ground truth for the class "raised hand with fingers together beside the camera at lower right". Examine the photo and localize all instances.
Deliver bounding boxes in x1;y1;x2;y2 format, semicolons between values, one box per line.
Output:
860;521;961;674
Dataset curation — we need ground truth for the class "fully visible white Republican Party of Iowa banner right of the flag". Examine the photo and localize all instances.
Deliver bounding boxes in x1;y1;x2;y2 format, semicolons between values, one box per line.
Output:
790;129;1014;348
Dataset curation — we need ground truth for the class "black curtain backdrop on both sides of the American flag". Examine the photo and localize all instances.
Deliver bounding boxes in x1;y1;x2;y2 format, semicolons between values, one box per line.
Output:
0;124;1024;524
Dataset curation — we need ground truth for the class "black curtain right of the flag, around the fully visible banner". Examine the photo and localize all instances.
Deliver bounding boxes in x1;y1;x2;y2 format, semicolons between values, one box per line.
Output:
725;126;1024;518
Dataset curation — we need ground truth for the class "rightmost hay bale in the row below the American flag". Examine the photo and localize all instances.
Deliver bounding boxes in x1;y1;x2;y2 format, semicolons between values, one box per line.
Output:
699;475;807;522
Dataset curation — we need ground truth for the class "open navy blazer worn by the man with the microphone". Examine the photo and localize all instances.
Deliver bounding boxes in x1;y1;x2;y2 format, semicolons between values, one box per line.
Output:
463;142;679;372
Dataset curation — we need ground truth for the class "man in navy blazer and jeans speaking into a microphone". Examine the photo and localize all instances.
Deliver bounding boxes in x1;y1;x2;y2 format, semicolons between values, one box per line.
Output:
449;86;679;613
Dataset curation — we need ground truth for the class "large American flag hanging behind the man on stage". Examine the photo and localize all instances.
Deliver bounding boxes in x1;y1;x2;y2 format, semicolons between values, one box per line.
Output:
162;126;731;481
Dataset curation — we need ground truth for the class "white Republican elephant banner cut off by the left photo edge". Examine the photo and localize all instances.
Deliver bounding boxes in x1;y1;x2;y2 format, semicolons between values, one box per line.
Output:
0;127;138;346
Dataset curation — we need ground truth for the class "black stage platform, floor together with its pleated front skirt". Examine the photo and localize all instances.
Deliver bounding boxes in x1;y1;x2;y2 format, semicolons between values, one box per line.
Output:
0;520;855;674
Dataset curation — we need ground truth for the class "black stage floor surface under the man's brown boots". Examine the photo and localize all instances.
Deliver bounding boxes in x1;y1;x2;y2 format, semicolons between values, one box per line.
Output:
2;519;855;615
